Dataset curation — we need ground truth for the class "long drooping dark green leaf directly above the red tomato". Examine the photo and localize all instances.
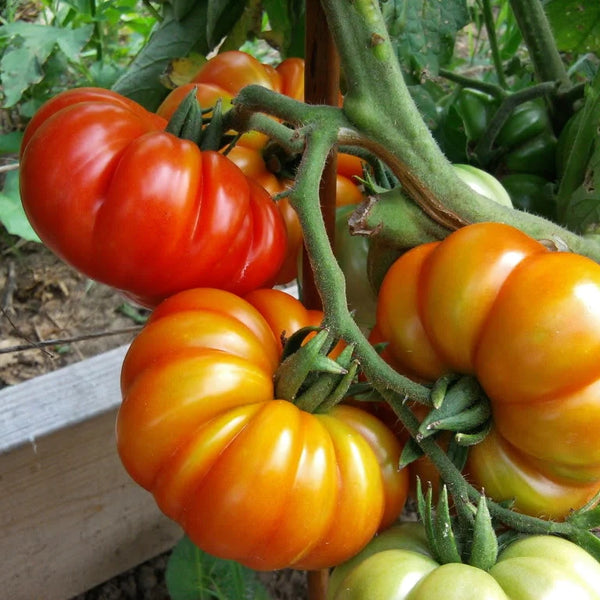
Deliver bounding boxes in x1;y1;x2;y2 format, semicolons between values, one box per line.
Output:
112;0;212;111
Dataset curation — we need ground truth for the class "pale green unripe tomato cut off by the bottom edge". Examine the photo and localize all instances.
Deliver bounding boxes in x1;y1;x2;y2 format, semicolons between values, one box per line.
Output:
327;523;600;600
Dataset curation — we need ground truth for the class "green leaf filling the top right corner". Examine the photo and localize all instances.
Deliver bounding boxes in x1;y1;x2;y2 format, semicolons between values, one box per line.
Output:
544;0;600;54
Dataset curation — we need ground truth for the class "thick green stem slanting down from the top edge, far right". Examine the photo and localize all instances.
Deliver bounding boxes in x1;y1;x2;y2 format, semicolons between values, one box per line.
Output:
510;0;571;88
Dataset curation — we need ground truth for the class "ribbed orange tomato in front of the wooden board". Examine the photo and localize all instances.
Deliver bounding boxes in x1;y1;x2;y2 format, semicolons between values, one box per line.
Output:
117;288;408;570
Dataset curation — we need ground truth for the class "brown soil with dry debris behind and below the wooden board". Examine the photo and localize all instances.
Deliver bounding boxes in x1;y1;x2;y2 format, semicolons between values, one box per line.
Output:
0;233;307;600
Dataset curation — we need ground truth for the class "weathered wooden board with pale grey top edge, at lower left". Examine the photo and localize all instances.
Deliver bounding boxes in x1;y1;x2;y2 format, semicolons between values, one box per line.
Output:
0;348;181;600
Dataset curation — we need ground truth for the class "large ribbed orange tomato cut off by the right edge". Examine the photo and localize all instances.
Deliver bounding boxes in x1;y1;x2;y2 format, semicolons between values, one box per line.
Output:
377;223;600;517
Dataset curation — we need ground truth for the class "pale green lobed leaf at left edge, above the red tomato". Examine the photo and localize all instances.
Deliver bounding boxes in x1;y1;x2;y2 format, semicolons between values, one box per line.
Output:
0;21;93;108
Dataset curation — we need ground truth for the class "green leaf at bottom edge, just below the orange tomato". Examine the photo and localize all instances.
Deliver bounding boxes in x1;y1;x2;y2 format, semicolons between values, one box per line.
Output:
166;537;270;600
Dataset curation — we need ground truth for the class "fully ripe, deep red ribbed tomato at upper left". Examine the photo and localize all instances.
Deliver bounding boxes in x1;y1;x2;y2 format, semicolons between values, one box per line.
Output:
20;88;286;306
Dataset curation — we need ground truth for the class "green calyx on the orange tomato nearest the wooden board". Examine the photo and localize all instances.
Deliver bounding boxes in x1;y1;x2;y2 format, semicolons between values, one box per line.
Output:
275;327;358;413
